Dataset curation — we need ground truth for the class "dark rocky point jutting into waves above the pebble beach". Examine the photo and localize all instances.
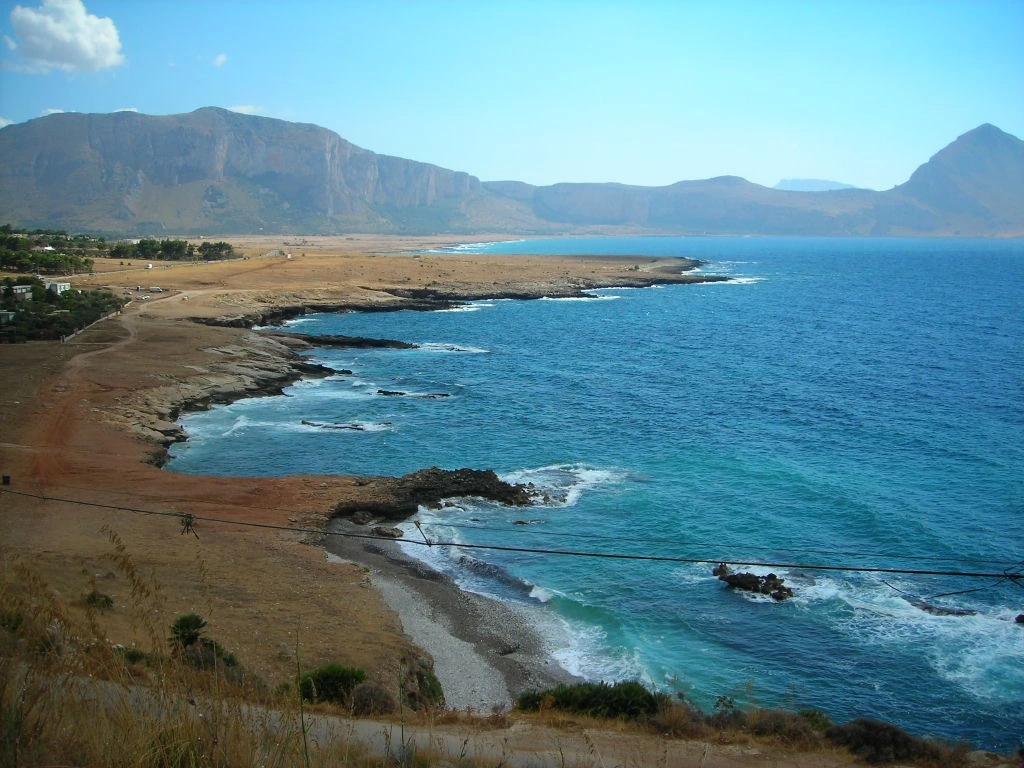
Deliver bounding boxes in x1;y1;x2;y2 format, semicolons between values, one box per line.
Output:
334;467;534;522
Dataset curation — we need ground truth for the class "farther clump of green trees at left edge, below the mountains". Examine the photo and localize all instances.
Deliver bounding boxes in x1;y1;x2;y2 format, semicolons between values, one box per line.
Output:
0;224;98;274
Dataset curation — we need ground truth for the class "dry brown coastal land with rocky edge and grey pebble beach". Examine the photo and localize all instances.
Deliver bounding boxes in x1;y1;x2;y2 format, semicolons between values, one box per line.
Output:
0;236;716;711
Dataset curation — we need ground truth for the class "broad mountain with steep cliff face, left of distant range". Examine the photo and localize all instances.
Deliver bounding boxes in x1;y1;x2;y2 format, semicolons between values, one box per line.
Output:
0;108;480;231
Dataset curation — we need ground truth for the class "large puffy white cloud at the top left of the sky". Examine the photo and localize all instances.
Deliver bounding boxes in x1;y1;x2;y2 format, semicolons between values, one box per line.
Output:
8;0;125;72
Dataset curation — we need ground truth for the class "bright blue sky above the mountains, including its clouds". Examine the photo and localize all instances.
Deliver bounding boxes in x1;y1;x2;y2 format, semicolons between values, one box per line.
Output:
0;0;1024;189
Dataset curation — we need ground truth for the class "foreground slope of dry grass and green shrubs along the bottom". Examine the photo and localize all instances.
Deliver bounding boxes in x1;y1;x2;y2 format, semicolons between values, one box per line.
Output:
0;530;983;768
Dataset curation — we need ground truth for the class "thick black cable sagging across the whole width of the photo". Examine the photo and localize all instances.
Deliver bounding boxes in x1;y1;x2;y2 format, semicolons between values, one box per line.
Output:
0;488;1024;584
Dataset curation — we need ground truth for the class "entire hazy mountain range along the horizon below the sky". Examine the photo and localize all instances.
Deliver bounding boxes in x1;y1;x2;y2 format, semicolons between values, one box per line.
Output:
0;108;1024;237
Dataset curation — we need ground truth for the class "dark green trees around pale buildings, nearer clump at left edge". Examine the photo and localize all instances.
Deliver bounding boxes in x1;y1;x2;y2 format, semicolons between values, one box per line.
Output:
0;278;125;341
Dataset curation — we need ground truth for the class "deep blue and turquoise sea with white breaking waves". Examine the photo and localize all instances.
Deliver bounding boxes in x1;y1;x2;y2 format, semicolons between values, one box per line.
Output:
169;238;1024;750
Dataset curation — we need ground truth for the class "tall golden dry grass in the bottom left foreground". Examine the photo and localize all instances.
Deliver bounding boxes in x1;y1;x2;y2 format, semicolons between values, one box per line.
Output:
0;548;528;768
